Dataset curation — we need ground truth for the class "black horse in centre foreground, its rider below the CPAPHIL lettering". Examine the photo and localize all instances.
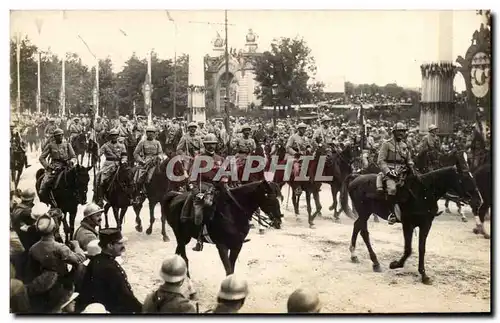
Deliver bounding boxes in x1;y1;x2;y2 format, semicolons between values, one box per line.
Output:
161;181;281;275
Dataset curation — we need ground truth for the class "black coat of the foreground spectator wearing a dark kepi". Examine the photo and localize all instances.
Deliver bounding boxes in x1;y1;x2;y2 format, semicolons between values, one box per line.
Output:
76;253;142;314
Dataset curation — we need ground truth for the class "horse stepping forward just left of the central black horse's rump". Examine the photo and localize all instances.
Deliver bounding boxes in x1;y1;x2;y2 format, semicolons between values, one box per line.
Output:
134;158;188;241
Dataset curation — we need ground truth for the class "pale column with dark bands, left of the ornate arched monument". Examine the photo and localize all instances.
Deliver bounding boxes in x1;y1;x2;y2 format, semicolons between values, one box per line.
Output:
188;54;207;122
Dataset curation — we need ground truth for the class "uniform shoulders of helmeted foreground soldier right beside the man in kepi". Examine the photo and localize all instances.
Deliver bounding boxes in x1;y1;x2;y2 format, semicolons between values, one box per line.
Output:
142;284;196;313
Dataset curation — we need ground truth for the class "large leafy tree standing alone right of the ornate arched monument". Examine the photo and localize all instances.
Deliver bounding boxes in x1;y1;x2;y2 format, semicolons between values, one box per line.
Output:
254;38;316;111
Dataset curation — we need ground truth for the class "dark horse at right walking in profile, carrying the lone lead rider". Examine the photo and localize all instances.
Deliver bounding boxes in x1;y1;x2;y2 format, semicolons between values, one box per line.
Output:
341;166;480;284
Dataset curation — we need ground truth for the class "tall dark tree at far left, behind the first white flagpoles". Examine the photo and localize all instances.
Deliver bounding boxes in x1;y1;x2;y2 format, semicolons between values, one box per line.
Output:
10;37;38;111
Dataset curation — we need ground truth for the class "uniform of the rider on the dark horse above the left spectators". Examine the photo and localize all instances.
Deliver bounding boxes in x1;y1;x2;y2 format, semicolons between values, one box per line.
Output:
39;135;76;195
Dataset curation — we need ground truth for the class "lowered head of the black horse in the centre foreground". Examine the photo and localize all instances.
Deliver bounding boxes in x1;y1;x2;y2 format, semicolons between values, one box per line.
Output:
257;180;283;229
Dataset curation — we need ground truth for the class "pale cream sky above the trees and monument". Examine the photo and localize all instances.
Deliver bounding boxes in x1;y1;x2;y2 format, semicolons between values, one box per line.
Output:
10;10;481;90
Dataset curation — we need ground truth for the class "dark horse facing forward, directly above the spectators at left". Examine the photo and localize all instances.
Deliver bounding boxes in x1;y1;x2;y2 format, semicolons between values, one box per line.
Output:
36;165;92;241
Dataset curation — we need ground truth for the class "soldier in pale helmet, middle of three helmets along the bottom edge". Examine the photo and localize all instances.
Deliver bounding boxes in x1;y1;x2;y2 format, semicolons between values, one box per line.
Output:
208;274;248;314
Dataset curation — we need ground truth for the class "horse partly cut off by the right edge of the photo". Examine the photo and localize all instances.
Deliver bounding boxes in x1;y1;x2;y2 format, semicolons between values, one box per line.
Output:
472;164;492;239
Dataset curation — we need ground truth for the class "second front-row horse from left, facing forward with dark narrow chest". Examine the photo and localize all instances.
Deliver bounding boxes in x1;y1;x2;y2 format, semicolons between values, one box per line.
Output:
99;163;140;230
